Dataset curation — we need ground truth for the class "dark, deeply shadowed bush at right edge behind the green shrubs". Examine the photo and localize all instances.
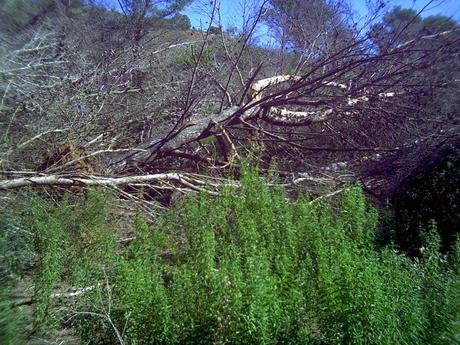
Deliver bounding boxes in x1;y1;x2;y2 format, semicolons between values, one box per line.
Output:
391;149;460;255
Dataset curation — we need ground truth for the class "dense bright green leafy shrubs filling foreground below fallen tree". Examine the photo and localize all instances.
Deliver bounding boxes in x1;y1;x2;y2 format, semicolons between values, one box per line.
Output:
2;168;460;344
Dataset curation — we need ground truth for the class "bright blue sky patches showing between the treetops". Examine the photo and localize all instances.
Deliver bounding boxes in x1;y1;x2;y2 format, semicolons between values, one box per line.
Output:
102;0;460;28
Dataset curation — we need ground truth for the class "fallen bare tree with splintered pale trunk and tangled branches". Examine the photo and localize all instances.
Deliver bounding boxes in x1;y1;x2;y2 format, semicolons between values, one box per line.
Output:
0;2;460;202
